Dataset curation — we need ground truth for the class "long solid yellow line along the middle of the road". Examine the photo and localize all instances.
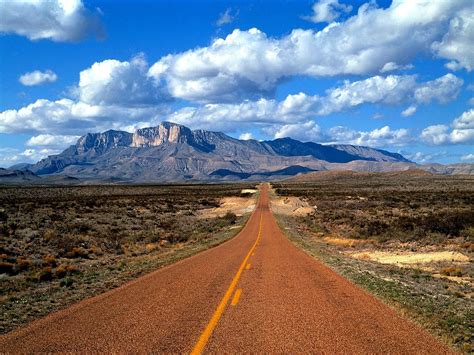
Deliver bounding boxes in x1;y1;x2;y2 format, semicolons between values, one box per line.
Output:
191;213;263;355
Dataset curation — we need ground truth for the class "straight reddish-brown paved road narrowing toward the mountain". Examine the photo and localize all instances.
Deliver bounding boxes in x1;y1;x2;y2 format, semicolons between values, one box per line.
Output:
0;186;449;354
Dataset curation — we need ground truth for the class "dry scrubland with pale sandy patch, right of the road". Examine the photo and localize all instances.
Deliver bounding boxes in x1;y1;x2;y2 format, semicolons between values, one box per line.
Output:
273;174;474;353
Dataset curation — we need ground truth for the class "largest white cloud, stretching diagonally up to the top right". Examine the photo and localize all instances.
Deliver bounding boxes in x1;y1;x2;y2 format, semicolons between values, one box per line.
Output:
149;0;471;103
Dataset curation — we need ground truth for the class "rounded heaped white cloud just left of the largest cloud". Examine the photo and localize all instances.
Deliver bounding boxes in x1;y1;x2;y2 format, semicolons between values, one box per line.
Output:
76;55;170;106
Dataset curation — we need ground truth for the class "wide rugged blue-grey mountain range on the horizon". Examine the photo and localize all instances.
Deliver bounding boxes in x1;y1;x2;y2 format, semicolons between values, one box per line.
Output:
27;122;413;182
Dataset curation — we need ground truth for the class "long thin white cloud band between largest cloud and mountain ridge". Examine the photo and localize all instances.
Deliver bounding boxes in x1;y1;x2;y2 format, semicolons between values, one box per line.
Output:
168;74;462;130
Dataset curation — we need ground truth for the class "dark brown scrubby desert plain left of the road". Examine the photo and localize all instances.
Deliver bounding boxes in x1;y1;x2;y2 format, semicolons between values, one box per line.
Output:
0;184;254;333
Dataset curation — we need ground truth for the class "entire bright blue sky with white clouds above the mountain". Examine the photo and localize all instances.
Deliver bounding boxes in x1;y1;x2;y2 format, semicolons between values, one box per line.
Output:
0;0;474;167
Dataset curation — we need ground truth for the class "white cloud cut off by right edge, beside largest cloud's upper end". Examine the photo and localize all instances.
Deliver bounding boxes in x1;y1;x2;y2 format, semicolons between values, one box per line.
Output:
432;8;474;71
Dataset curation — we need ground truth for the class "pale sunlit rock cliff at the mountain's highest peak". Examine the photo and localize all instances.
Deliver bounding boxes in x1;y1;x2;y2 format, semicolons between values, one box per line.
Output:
131;122;193;147
